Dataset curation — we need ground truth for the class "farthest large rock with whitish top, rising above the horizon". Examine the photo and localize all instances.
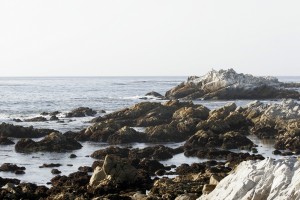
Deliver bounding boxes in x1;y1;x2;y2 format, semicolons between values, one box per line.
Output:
165;69;300;99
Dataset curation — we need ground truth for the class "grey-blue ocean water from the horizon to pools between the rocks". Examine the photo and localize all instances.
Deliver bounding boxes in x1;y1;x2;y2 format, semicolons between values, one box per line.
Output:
0;76;300;184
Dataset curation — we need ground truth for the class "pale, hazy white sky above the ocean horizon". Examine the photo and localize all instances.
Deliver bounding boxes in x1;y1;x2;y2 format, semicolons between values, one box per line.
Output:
0;0;300;76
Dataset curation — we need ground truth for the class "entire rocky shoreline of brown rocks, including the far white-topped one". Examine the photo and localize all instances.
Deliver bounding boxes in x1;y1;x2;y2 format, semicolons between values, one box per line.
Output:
0;70;300;200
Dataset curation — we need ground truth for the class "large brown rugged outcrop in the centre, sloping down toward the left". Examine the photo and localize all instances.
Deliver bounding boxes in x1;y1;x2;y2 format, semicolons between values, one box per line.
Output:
81;100;209;144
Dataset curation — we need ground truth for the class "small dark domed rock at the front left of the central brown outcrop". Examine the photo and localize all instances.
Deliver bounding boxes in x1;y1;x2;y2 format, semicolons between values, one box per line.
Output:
107;126;146;144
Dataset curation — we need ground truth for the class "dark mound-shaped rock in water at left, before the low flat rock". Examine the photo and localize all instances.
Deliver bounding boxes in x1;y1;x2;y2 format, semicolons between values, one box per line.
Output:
15;132;82;152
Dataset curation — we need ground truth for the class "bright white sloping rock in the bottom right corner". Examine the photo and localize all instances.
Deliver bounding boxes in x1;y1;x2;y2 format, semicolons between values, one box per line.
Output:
199;158;300;200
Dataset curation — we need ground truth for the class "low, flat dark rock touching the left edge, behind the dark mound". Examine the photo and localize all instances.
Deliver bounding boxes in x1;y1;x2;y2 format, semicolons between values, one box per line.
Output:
0;122;57;138
